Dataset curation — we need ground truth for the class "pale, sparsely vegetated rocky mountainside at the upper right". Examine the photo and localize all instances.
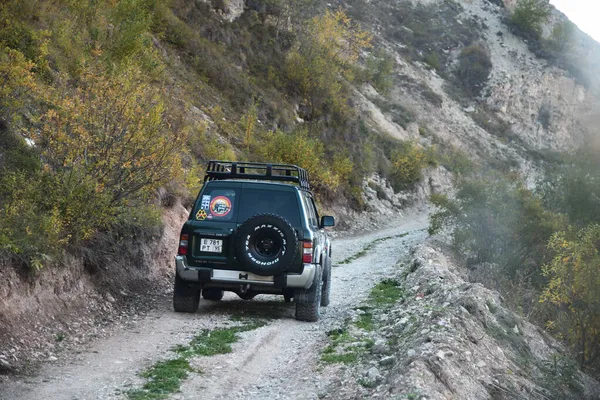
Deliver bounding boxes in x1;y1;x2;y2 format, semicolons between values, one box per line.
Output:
348;0;600;158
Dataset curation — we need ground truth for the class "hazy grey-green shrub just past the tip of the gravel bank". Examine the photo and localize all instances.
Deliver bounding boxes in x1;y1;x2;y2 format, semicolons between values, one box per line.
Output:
429;175;566;287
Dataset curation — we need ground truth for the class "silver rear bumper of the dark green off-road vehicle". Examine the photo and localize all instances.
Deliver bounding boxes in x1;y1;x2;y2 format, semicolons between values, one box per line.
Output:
175;256;316;289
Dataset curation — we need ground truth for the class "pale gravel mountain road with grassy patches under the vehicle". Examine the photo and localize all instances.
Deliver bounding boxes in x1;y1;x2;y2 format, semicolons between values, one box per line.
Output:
0;214;427;400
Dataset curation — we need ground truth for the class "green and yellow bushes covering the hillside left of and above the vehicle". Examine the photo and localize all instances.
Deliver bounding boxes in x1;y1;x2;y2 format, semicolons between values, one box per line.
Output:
0;0;429;272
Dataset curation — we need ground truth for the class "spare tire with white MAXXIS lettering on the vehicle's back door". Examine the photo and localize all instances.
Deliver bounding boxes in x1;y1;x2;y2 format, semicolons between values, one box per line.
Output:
235;214;298;276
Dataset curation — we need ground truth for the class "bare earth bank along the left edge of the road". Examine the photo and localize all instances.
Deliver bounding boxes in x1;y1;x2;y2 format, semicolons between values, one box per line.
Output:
0;204;187;371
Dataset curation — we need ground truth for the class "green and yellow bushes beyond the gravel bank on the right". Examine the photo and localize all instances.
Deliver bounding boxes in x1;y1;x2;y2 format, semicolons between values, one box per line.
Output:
429;148;600;373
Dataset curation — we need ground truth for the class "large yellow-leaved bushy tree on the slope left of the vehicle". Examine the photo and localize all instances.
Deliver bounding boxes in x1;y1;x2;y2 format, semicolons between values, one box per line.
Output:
26;63;185;205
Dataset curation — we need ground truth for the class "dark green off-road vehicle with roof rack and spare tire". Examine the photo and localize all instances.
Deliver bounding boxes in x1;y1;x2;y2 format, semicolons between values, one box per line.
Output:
173;161;334;321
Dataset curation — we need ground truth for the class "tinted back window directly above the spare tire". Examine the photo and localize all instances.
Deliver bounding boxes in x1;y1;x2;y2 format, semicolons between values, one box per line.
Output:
237;188;301;227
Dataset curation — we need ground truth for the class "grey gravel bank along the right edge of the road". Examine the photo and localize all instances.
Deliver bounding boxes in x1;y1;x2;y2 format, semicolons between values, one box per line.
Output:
324;239;600;399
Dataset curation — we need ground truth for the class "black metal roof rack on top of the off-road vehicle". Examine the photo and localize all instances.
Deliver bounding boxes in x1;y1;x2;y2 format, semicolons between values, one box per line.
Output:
204;160;310;191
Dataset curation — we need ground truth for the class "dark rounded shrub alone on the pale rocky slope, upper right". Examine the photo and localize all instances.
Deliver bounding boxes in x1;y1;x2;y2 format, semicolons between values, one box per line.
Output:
456;44;492;96
